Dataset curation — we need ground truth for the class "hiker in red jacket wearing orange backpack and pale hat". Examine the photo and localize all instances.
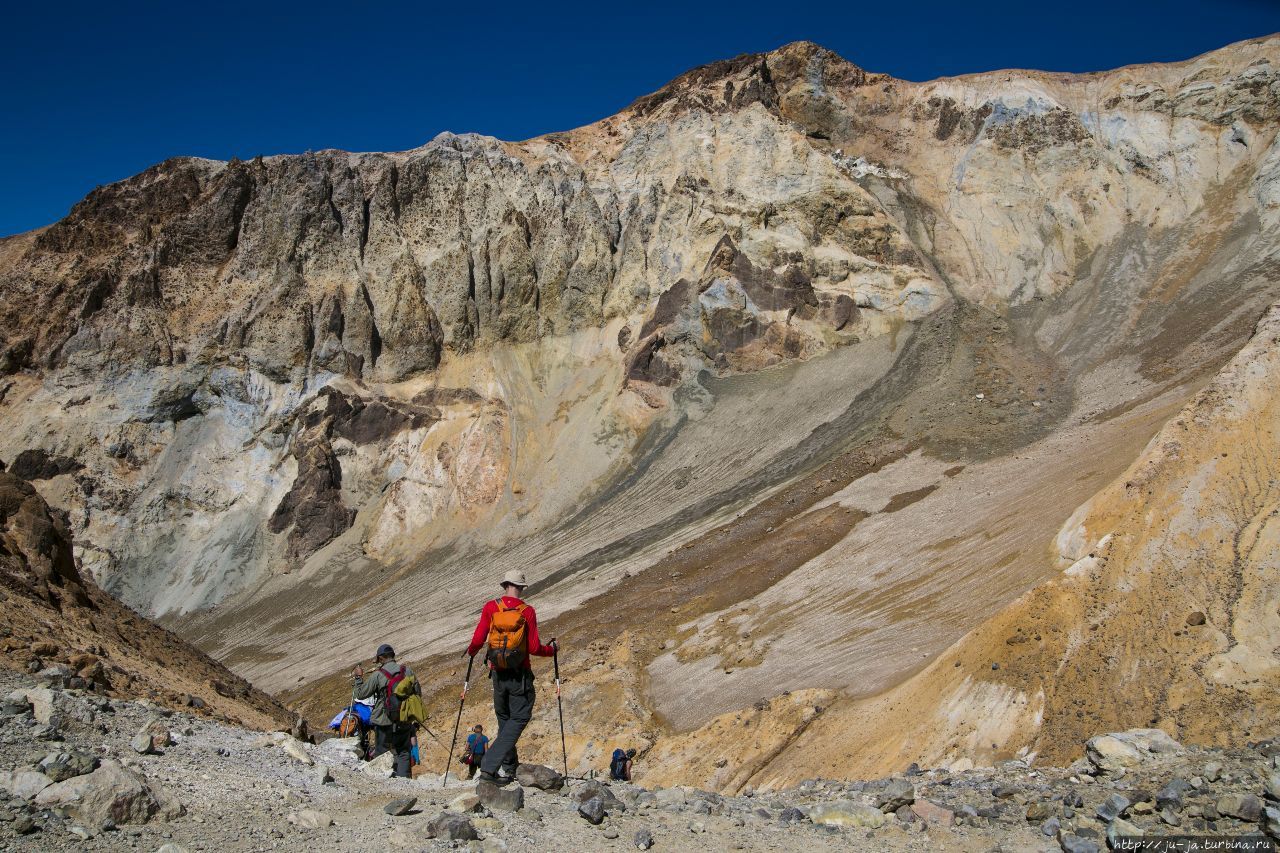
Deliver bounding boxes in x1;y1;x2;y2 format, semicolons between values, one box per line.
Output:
466;570;557;785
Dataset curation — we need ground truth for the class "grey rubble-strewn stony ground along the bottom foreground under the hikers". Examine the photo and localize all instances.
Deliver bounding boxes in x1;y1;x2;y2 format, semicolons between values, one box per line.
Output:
0;672;1280;853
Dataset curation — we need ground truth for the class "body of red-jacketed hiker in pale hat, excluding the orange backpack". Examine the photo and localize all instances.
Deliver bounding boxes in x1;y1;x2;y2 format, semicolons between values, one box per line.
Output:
466;570;557;784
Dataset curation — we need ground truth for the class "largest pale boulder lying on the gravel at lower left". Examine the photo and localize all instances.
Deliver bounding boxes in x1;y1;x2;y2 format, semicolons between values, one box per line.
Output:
36;760;183;826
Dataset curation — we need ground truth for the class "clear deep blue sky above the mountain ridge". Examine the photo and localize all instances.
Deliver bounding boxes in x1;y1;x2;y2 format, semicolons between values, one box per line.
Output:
0;0;1280;234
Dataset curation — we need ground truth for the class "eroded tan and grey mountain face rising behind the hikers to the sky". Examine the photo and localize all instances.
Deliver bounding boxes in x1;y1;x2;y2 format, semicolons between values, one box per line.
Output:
0;38;1280;784
